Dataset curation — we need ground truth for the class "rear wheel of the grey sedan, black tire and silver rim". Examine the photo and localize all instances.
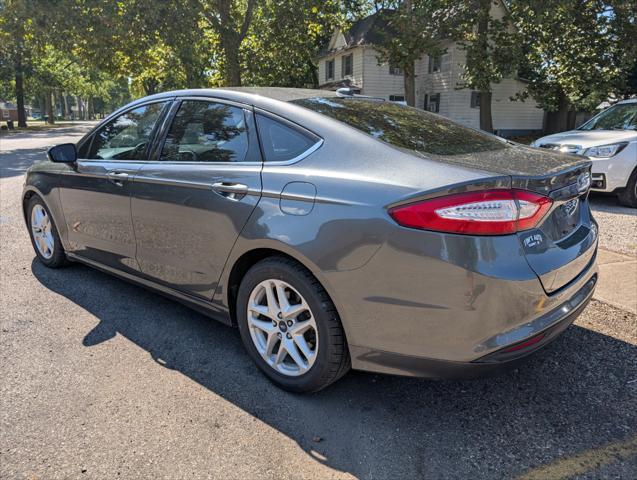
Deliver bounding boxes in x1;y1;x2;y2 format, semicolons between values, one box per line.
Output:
236;257;351;393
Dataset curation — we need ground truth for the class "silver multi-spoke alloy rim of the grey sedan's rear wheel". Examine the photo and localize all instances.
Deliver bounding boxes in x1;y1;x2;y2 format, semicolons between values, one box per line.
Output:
247;279;319;376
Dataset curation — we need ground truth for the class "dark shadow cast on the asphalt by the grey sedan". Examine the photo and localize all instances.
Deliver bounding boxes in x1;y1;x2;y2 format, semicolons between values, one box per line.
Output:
32;260;637;478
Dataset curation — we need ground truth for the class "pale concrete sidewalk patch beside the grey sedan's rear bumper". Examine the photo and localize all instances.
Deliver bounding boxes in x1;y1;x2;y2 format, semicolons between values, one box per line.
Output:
593;248;637;314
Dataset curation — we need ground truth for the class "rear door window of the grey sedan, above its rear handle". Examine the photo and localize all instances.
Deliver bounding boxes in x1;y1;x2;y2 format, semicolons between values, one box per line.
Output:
161;100;249;162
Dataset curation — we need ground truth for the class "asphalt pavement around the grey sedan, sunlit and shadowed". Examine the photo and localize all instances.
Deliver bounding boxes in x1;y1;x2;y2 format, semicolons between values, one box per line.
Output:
0;129;637;479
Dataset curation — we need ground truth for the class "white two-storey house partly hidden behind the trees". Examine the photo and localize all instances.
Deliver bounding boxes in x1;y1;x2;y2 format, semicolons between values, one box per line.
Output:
318;2;544;137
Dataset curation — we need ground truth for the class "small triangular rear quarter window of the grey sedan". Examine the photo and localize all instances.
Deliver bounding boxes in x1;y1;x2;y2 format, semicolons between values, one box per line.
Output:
257;114;320;162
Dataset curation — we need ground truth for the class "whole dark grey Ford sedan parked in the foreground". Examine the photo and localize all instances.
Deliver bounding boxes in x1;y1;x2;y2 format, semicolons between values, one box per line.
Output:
23;88;597;392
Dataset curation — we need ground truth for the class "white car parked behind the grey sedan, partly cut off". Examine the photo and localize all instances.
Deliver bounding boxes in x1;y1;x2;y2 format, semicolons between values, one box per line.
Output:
531;99;637;207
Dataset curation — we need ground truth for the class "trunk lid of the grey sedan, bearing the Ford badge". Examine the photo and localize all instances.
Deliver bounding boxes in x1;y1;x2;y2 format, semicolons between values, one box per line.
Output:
422;148;597;294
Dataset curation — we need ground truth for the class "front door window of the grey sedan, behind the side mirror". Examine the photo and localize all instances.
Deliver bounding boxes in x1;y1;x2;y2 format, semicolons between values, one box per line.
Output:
87;102;166;160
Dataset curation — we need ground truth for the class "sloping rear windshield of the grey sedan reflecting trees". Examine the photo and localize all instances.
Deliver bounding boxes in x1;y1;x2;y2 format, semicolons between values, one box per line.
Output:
292;98;509;155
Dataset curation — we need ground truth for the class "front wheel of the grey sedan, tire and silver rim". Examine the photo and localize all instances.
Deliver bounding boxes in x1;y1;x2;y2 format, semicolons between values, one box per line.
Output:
26;195;68;268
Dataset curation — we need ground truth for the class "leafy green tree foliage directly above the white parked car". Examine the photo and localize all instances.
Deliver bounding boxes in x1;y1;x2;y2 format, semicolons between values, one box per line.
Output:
511;0;637;131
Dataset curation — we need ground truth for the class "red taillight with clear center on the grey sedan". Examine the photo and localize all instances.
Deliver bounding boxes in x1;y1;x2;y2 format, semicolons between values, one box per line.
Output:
389;190;552;235
